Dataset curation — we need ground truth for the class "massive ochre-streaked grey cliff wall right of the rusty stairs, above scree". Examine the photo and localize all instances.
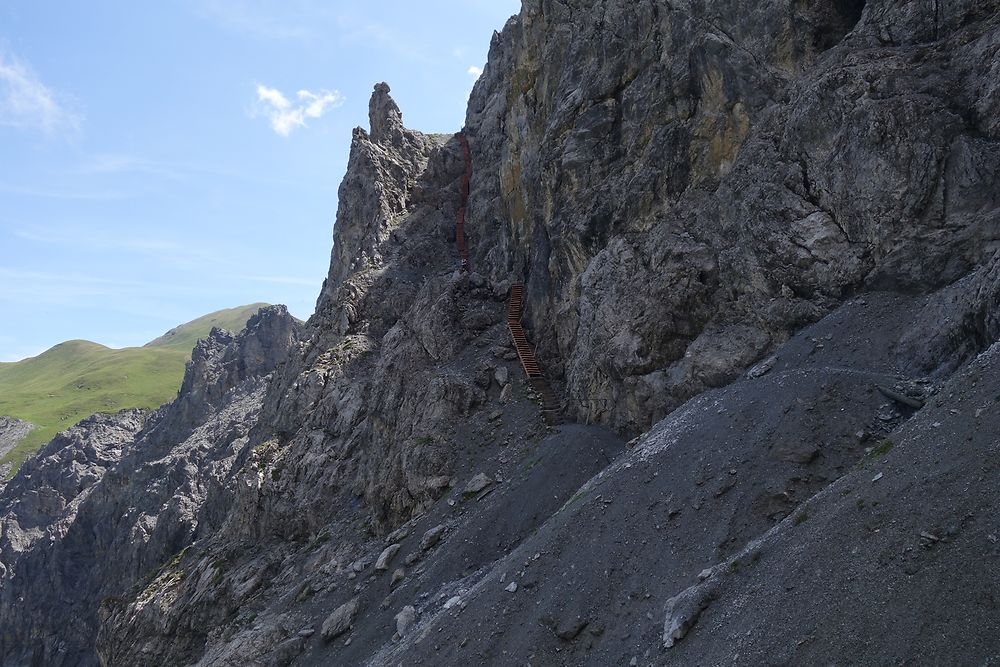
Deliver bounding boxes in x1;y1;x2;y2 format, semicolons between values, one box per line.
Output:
454;1;998;431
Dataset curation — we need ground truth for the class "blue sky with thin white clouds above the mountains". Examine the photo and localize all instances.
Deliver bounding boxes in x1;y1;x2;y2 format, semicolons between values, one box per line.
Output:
0;0;520;361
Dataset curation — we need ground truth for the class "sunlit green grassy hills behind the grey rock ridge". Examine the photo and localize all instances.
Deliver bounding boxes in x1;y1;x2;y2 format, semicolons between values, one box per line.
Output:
0;303;266;470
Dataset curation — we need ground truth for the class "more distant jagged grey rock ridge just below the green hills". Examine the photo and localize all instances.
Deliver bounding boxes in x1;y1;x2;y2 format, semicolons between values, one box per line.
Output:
0;307;296;665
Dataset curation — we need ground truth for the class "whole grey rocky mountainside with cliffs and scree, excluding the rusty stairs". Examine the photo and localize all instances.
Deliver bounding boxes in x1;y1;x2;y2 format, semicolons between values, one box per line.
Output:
0;0;1000;665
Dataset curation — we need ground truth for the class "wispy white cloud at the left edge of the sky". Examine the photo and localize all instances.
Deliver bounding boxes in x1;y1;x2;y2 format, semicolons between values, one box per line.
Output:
0;53;80;135
